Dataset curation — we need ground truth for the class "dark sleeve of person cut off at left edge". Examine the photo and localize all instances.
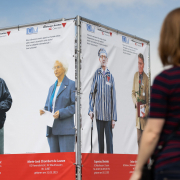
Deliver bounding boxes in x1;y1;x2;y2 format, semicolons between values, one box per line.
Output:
0;81;12;112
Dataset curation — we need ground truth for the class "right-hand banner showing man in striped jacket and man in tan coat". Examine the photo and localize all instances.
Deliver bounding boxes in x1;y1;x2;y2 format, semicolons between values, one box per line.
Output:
81;22;149;177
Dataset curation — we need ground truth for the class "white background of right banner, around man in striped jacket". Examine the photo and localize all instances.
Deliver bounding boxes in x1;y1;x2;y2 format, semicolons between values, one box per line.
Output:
81;22;149;154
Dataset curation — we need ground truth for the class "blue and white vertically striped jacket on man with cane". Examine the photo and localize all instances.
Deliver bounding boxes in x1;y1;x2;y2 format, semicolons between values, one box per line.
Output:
88;68;117;121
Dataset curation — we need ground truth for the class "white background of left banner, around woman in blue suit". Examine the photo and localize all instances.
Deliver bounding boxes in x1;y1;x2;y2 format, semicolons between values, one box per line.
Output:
0;20;75;154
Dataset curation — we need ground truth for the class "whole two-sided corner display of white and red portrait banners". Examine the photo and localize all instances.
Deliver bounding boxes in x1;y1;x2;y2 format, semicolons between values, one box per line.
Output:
0;16;151;180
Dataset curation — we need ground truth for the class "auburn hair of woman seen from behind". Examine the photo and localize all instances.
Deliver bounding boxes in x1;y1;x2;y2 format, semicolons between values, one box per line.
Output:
159;8;180;66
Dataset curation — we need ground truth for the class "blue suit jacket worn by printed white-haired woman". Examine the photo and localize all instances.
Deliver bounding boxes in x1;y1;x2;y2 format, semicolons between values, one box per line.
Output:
44;75;75;136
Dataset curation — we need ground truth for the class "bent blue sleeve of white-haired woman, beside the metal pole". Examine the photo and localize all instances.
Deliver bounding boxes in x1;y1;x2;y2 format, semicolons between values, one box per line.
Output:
59;81;75;119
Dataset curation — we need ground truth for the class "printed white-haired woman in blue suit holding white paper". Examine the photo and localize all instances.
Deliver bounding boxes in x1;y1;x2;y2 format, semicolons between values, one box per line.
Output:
40;60;75;152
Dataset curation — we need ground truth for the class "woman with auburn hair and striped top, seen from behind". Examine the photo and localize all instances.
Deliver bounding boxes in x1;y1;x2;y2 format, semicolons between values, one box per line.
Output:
130;8;180;180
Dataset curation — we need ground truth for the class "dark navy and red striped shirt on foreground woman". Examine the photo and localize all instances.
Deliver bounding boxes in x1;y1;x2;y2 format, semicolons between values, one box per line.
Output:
149;66;180;170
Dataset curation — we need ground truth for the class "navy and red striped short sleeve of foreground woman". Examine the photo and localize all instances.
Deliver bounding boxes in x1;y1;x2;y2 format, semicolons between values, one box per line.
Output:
149;74;170;118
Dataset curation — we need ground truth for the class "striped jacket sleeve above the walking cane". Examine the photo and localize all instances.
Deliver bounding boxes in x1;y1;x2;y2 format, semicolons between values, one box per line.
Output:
88;73;97;115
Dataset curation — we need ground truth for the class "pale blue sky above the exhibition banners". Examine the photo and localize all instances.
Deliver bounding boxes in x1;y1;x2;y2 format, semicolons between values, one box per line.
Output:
0;0;180;82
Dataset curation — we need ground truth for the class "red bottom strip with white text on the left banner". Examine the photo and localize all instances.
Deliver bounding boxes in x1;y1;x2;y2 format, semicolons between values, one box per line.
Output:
0;152;75;180
